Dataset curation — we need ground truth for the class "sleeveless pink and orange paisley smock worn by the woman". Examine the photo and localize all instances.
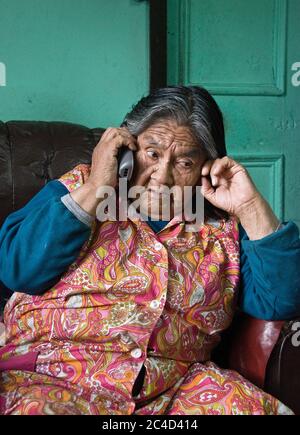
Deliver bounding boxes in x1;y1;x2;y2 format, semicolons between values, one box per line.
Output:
0;165;288;415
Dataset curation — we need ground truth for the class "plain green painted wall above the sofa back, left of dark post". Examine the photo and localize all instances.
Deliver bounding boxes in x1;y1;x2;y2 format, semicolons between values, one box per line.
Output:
0;0;149;127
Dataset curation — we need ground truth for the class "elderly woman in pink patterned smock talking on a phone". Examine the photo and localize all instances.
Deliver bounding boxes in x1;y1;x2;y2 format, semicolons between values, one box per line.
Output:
0;86;300;415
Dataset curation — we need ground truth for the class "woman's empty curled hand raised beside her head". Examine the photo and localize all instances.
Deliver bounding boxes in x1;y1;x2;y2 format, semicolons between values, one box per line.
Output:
201;157;261;217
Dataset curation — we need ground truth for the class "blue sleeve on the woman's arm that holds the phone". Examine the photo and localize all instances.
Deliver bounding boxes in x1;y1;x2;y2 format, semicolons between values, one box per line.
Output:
0;180;91;294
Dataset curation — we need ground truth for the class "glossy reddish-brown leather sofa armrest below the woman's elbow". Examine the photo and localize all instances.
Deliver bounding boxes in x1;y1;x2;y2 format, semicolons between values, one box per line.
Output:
213;313;300;415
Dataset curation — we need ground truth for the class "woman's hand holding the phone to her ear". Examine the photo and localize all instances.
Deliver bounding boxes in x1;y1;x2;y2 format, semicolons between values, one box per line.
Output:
87;127;137;189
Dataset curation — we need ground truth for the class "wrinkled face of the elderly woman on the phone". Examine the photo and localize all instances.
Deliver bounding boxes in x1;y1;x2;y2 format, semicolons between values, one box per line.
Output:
129;120;206;218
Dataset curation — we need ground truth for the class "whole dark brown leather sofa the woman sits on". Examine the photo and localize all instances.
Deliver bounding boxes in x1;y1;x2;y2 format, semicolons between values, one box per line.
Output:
0;121;300;414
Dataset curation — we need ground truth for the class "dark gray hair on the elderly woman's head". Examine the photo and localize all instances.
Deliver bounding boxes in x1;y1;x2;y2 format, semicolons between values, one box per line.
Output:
121;86;226;159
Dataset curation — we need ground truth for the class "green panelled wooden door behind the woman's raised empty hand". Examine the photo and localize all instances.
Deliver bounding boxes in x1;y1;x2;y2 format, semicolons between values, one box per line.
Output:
168;0;300;227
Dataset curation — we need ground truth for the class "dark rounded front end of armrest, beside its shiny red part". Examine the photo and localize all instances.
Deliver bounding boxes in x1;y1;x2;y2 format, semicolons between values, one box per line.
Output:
264;318;300;415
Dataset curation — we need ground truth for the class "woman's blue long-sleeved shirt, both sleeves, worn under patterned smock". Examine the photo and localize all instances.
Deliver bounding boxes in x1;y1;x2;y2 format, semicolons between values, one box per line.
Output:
0;180;300;320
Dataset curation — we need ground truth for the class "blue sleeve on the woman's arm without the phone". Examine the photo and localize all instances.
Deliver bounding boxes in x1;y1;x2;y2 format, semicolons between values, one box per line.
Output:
239;222;300;320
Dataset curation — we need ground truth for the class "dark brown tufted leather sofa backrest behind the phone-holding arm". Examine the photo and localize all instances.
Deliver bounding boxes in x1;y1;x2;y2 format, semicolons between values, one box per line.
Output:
0;121;104;226
